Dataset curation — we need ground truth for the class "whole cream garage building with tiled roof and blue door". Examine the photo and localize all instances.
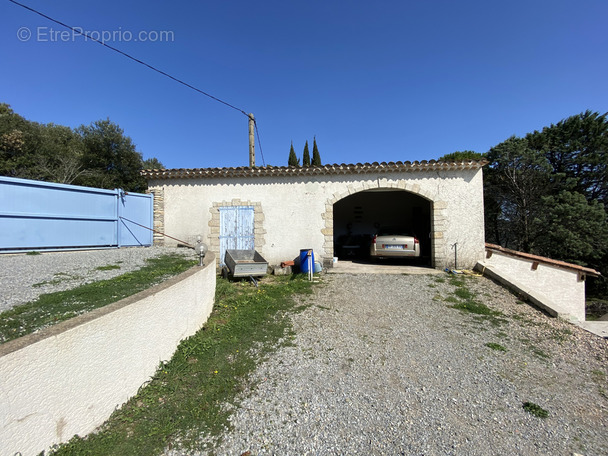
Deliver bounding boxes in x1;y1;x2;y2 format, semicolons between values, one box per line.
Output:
143;160;485;268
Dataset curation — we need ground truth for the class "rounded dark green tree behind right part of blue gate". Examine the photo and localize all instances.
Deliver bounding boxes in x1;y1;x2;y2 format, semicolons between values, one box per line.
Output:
77;119;147;192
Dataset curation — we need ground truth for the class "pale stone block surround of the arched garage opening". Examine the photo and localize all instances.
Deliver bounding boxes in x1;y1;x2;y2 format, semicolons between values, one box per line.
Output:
323;181;447;266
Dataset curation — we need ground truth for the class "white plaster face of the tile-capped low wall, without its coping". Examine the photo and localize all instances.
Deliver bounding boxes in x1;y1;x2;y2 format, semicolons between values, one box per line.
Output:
483;252;585;321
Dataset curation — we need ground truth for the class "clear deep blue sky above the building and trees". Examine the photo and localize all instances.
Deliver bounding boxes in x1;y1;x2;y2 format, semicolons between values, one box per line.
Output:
0;0;608;168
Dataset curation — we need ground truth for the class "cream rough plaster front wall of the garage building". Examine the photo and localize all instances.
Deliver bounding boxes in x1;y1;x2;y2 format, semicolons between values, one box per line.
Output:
149;170;485;268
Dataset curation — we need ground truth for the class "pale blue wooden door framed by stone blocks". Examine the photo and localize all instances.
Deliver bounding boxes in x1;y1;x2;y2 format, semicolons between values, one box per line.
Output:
220;206;255;266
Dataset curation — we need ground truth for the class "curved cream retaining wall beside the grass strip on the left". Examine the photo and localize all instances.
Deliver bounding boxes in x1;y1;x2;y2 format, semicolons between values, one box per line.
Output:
0;255;216;456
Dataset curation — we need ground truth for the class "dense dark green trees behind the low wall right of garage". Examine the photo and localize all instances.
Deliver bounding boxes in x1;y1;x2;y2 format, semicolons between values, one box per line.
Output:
484;111;608;296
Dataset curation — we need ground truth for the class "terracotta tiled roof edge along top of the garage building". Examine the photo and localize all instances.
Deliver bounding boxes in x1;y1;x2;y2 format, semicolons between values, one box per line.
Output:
142;160;488;179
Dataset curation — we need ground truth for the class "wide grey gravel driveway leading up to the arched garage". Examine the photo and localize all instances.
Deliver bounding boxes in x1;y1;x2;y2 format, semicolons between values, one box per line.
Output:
205;275;608;456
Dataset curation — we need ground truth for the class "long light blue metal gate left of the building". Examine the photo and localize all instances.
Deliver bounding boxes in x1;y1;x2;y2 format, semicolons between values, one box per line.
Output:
0;177;152;252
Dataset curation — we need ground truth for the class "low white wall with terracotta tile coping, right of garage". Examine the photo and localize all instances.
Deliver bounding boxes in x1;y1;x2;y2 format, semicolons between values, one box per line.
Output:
476;244;599;321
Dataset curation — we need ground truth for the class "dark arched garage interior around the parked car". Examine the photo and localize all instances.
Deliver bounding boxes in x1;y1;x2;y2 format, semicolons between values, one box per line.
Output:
333;189;433;266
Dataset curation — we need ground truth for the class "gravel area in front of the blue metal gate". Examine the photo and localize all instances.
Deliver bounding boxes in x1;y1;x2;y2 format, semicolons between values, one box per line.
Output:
0;247;194;312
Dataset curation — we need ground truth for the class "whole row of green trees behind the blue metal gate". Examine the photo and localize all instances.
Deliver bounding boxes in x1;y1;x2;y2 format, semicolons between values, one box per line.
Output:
0;103;164;191
